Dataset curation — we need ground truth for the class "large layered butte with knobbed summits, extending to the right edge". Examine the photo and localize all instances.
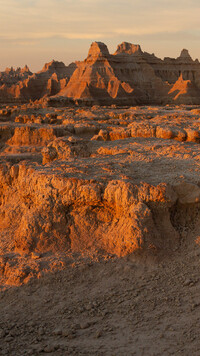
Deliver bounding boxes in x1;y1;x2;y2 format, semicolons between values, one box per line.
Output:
56;42;200;105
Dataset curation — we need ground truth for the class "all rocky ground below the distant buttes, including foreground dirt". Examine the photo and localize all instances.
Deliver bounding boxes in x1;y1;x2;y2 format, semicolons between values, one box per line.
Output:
0;101;200;356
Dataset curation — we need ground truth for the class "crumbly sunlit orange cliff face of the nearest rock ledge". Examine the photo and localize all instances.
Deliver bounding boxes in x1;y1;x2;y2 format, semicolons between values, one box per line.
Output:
1;164;178;255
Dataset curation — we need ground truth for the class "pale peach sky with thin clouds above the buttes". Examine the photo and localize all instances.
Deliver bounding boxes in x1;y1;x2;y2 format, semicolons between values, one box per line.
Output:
0;0;200;72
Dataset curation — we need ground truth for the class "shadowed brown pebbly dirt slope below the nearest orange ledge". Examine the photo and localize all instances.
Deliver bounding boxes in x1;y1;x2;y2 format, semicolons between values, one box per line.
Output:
0;229;200;356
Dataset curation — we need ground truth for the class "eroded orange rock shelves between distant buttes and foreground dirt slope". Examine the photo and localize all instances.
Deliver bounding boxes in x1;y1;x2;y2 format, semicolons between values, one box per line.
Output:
0;103;200;283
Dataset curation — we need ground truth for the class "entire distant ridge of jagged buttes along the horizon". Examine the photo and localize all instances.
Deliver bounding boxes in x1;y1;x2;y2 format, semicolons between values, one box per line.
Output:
0;42;200;105
